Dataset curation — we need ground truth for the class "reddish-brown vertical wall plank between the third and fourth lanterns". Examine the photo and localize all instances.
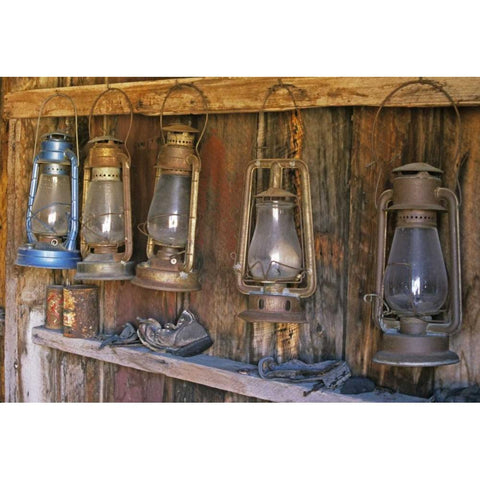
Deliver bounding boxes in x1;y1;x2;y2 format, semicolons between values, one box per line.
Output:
189;110;256;361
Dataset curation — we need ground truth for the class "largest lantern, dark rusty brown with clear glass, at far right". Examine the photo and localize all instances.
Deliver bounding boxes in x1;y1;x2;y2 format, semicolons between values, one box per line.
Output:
373;80;462;367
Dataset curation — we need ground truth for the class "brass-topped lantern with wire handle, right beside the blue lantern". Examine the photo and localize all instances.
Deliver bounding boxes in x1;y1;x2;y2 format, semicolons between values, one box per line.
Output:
75;88;135;280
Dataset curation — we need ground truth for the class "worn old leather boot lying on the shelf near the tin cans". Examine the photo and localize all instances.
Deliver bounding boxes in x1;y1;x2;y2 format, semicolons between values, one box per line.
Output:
137;310;213;357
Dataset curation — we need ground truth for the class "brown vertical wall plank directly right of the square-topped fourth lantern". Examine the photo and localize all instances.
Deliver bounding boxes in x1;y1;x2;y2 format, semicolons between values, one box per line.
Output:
300;108;352;363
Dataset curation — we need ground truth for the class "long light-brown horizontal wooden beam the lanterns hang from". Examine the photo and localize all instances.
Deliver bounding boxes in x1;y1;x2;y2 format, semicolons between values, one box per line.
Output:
4;77;480;118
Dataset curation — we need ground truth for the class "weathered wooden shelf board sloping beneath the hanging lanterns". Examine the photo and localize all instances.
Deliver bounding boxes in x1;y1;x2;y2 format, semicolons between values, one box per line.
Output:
32;327;427;402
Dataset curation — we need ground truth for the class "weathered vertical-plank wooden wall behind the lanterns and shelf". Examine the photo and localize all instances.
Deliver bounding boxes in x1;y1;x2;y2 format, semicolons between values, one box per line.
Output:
0;79;480;402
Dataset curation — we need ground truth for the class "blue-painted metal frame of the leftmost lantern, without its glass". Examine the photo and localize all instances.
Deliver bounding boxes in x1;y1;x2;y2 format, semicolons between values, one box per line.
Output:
15;132;81;270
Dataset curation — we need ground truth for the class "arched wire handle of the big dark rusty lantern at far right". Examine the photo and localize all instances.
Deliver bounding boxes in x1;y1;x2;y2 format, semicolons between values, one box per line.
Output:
367;77;462;208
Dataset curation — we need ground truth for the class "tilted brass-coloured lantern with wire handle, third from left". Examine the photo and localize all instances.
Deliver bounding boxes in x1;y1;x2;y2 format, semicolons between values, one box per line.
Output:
132;84;208;292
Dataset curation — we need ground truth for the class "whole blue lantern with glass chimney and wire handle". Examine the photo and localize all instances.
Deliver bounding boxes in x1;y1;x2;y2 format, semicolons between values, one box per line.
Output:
15;94;81;269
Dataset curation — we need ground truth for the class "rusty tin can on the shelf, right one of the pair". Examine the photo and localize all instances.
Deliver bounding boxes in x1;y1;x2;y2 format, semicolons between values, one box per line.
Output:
63;285;99;338
